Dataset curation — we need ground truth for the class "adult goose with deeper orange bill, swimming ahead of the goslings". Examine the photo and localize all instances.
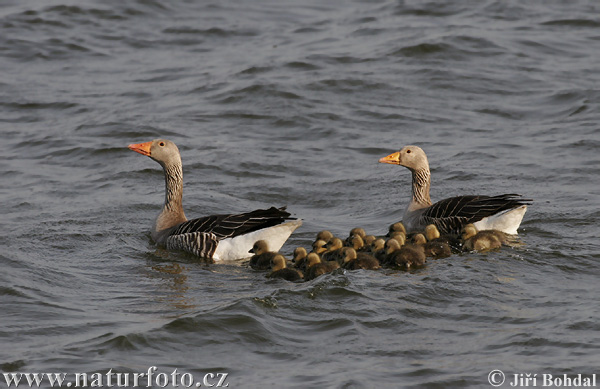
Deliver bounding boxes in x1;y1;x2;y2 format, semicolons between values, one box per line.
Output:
129;139;302;261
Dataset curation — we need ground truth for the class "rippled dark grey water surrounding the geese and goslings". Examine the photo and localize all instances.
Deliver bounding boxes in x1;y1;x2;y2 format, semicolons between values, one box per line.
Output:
0;0;600;388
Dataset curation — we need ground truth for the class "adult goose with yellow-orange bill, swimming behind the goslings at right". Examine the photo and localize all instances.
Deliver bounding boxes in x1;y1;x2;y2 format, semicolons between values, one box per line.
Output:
379;146;532;235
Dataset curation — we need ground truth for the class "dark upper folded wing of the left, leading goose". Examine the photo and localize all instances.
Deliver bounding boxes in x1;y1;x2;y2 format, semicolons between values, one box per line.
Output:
169;207;294;240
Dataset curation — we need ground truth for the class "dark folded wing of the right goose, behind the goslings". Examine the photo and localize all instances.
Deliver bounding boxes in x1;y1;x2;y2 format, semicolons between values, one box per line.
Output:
419;194;531;234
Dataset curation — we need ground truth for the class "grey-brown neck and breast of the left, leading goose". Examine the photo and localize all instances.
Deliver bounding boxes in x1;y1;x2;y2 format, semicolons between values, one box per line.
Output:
152;159;187;244
